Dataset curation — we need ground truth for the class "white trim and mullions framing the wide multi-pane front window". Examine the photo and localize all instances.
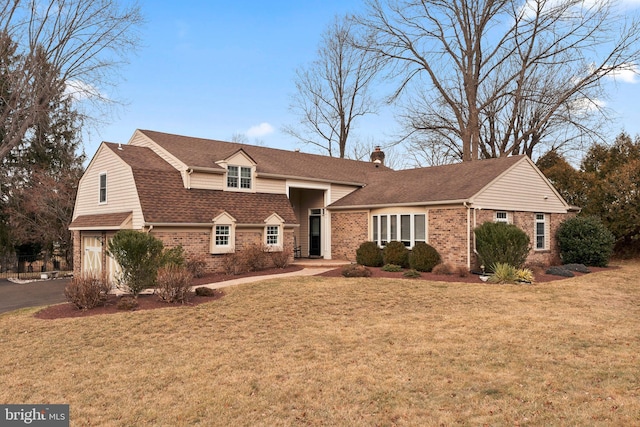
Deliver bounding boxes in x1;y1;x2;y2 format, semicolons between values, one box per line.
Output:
370;212;429;249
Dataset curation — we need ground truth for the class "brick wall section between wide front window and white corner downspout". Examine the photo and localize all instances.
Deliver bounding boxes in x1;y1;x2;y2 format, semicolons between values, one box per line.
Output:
428;208;467;267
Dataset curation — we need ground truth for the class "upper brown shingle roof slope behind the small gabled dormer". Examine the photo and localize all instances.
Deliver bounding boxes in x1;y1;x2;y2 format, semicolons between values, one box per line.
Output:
139;130;391;184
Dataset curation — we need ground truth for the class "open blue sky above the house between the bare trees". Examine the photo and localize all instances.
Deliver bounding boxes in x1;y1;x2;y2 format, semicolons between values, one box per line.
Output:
84;0;640;162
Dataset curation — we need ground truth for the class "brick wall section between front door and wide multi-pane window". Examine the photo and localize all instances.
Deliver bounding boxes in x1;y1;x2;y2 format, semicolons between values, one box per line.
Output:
331;211;371;261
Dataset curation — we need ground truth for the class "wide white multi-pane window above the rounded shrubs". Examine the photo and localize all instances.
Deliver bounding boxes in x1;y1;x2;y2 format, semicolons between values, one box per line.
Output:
371;214;427;248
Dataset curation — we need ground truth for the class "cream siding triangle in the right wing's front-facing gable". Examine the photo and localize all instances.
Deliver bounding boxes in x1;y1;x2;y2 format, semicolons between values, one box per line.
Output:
473;159;567;213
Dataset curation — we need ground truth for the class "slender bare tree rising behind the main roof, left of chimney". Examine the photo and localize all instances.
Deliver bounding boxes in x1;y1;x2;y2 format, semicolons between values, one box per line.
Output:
284;18;377;158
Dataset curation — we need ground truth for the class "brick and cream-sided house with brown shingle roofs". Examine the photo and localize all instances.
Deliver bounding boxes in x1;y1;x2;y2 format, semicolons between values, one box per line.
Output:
70;130;571;284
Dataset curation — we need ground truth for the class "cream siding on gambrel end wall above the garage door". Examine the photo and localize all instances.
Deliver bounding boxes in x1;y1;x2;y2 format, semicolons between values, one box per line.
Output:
73;145;144;229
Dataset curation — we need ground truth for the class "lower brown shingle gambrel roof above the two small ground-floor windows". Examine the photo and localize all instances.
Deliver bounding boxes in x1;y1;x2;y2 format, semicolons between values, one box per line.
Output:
104;143;298;224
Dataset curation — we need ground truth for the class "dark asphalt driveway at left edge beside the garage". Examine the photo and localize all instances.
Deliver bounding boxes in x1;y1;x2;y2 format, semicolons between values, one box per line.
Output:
0;279;71;313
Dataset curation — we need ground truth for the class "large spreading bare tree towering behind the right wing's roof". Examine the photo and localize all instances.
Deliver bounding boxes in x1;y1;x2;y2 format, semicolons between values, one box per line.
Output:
358;0;640;160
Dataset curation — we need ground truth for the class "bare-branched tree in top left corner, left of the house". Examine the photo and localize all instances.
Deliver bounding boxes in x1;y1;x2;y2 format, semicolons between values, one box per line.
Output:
0;0;142;159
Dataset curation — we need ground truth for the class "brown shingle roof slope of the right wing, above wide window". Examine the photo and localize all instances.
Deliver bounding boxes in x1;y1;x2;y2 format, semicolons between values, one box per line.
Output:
330;156;525;208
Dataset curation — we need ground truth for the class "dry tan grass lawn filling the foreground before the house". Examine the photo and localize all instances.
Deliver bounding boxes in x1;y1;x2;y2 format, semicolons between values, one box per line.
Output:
0;262;640;426
